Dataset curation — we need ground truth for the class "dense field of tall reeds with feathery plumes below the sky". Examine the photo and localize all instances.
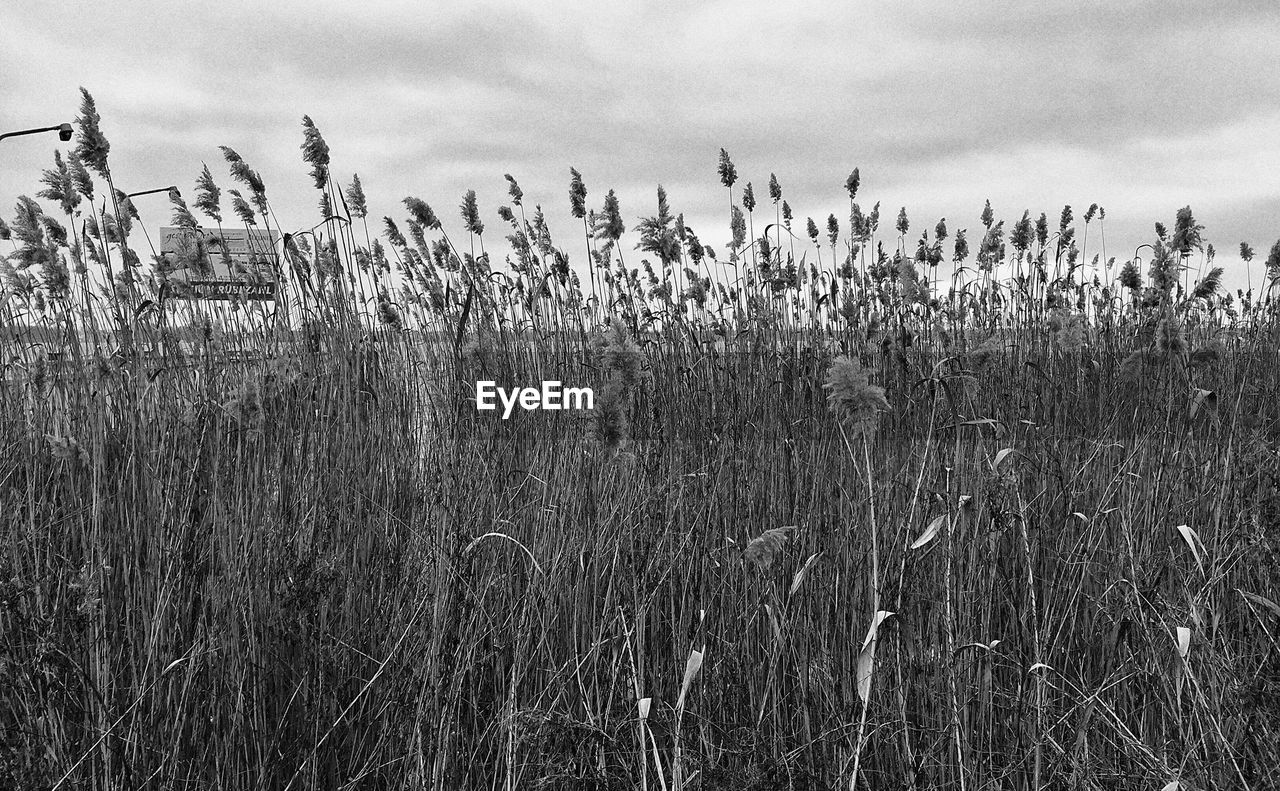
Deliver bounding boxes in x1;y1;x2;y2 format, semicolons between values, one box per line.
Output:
0;87;1280;790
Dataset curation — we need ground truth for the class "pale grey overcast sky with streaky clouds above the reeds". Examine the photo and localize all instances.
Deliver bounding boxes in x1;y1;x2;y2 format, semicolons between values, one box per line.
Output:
0;0;1280;293
